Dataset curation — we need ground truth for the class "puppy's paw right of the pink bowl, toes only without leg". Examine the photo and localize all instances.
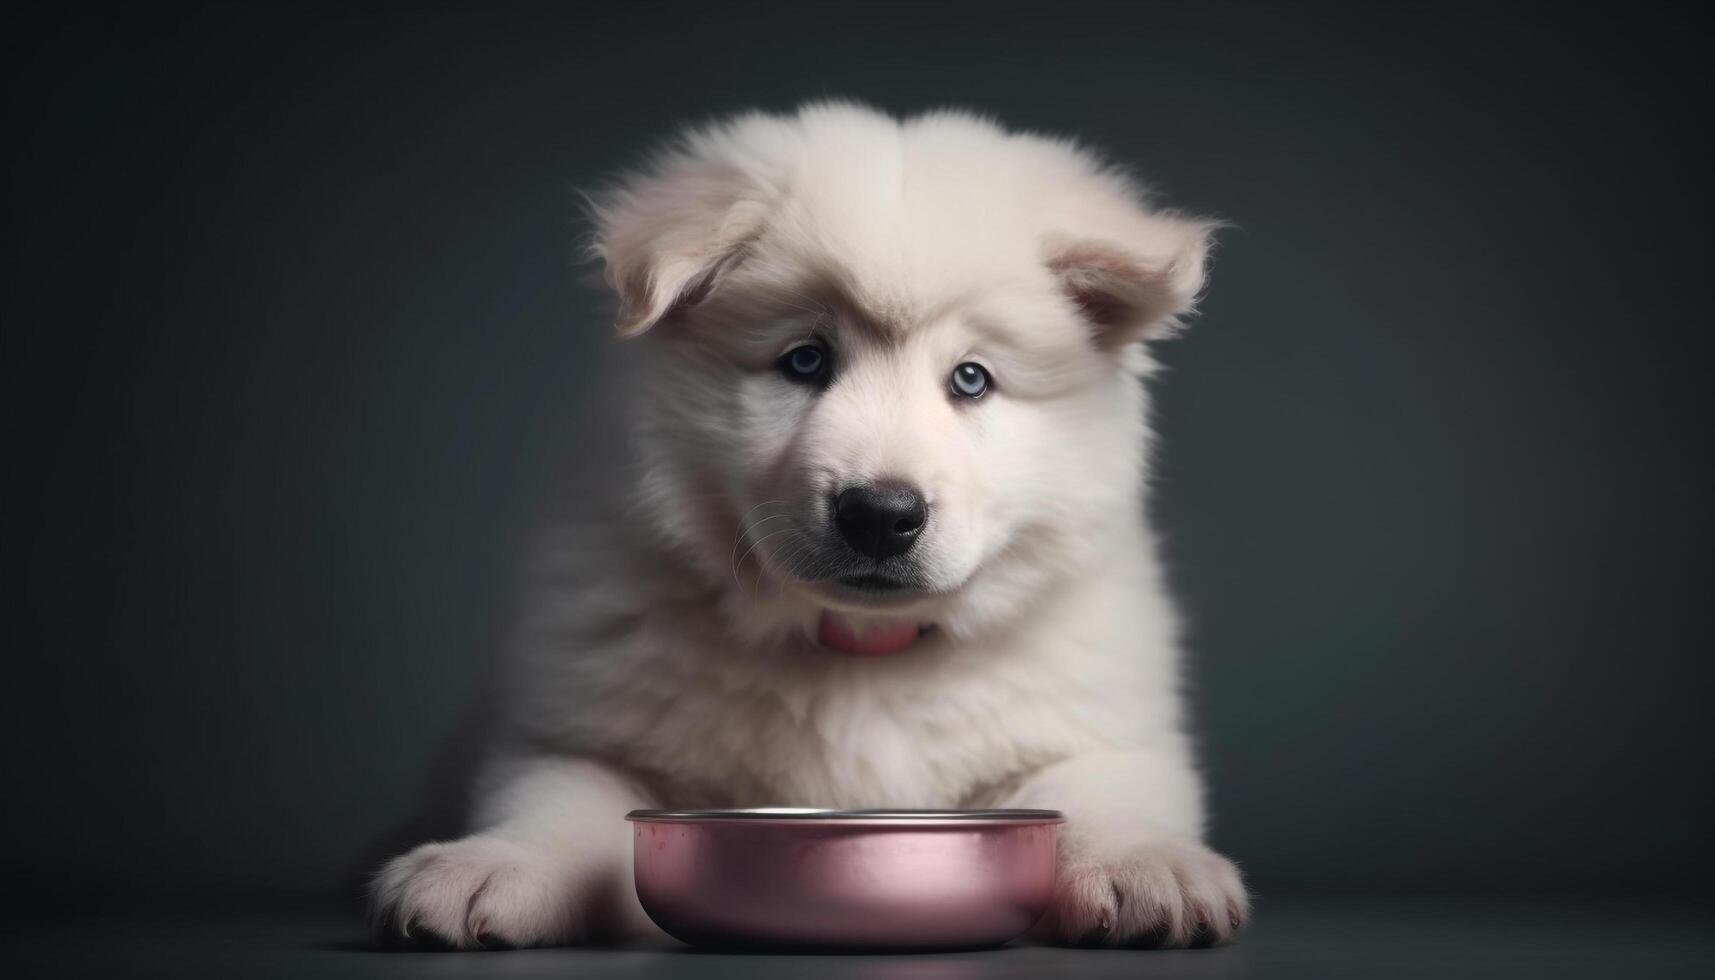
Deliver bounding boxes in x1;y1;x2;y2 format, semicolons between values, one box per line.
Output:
1041;841;1250;947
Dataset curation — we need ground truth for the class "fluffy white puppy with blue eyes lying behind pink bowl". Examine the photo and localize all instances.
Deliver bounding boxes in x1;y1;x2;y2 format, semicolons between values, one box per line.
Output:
372;105;1247;947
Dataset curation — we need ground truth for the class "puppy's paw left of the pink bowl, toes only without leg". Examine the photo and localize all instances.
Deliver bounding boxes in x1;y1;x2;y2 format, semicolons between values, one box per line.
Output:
369;836;590;949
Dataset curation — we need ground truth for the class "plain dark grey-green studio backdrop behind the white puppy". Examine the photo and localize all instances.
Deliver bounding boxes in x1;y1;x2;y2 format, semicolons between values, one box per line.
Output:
0;2;1715;908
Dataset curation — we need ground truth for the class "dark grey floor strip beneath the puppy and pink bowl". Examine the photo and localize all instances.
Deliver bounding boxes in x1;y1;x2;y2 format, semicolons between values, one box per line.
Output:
16;898;1715;980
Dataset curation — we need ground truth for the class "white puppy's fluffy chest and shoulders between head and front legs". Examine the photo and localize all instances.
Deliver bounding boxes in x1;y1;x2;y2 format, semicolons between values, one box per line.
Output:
508;521;1178;808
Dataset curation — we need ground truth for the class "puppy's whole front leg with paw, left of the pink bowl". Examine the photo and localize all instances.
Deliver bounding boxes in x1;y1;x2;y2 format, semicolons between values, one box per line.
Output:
370;757;653;949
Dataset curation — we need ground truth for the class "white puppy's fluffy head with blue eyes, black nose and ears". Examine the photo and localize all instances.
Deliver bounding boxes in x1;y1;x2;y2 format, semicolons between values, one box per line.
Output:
595;105;1211;652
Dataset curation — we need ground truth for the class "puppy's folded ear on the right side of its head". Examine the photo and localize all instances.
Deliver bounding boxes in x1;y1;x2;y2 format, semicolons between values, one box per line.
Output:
1048;211;1218;350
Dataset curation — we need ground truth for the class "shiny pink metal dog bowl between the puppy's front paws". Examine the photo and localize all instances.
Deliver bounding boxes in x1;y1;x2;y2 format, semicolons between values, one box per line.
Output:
626;808;1065;949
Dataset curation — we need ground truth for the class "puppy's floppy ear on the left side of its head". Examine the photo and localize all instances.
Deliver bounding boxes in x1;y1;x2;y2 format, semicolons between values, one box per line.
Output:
592;154;765;338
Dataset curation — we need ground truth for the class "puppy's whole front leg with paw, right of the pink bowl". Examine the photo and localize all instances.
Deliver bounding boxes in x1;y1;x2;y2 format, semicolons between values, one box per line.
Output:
1005;745;1250;947
